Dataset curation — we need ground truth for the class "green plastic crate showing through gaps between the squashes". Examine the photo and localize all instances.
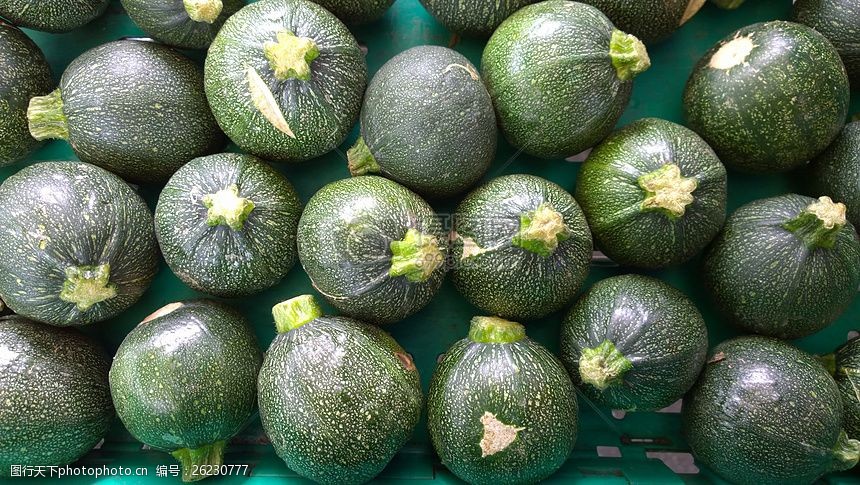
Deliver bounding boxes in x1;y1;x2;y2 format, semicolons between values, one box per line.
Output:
5;0;860;484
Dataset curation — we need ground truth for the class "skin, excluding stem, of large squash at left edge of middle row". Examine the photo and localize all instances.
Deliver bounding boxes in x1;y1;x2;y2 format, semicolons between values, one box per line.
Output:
0;162;158;326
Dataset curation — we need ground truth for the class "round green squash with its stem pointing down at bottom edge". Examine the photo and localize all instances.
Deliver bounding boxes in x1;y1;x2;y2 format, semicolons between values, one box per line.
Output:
110;300;263;482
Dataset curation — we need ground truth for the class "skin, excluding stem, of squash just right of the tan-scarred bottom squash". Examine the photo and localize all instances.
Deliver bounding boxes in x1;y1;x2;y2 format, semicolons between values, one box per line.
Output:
561;274;708;411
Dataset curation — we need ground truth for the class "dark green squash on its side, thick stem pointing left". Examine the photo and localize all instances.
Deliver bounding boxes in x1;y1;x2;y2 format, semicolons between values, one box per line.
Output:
27;40;225;182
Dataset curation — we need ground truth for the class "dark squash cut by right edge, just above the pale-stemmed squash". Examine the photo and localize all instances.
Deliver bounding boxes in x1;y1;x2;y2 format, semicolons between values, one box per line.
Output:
810;121;860;228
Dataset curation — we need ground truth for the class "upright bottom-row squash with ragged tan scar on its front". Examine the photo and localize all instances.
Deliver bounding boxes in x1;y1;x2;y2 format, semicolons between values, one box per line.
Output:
427;317;578;484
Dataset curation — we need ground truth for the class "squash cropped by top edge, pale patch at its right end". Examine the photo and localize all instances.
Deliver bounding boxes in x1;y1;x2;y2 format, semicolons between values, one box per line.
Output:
583;0;705;44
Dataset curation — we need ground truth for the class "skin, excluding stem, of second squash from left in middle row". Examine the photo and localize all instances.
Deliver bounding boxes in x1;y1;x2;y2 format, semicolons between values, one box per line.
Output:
155;153;302;296
